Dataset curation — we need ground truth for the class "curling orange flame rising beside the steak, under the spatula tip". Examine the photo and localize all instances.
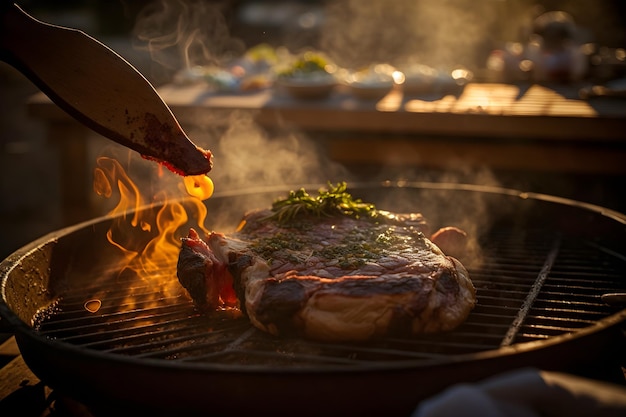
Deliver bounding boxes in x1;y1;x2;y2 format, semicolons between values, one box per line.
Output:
93;157;213;303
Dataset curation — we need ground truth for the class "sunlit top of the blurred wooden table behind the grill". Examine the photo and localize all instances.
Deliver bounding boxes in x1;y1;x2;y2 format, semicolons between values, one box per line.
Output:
158;83;626;141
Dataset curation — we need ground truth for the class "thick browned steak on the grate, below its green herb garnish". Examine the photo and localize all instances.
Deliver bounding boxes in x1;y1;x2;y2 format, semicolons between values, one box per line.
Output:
178;185;475;341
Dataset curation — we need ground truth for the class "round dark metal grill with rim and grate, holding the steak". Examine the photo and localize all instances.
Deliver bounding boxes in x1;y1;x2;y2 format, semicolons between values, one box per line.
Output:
0;183;626;416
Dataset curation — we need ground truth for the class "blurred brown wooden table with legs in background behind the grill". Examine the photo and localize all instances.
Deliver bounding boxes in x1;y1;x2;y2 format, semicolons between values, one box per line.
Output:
28;83;626;224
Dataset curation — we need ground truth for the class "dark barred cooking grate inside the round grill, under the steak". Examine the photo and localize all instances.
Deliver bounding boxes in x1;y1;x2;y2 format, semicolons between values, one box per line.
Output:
36;231;626;368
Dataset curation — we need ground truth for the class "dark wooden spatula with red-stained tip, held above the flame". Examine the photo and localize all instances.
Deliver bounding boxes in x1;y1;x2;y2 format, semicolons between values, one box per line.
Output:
0;2;211;175
